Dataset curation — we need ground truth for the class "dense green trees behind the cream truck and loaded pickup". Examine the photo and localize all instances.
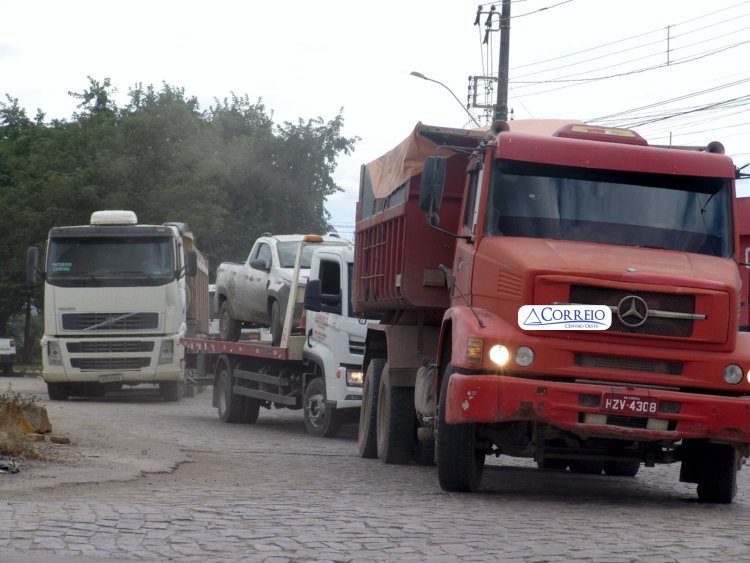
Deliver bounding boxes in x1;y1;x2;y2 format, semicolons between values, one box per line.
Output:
0;77;357;334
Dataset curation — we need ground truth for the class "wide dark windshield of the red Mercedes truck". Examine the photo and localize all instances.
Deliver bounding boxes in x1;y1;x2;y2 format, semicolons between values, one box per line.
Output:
484;160;734;257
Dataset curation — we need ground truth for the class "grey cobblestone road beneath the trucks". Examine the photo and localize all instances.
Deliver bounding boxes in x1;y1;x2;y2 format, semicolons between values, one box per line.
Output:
0;379;750;562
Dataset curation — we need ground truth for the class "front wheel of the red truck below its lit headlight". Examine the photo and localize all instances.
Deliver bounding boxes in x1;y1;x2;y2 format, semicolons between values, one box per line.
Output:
437;364;486;493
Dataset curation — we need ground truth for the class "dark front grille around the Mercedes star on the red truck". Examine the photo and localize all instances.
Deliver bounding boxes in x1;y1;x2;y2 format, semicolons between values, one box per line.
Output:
570;285;695;338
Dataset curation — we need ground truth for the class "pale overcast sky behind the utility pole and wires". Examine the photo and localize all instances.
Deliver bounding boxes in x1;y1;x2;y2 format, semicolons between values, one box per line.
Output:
0;0;750;238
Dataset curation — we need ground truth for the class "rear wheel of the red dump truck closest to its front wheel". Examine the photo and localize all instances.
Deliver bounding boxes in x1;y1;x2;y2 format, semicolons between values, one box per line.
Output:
377;364;417;465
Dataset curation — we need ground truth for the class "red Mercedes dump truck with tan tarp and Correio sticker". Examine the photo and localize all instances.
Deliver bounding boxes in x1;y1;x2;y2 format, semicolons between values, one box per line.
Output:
353;120;750;503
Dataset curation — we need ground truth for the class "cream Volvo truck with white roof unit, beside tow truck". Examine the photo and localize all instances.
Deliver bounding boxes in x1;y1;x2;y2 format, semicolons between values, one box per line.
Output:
27;211;208;401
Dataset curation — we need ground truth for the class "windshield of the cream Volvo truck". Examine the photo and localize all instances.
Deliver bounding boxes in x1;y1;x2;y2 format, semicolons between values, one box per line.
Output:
47;236;177;287
